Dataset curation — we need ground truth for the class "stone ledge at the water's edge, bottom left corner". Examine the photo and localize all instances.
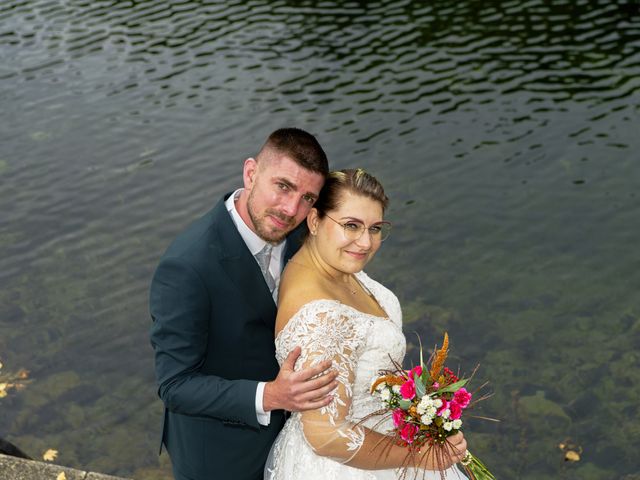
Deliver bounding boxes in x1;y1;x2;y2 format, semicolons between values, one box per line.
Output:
0;454;127;480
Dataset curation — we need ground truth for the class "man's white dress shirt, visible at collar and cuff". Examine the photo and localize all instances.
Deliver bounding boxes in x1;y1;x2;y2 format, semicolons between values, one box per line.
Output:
225;188;286;426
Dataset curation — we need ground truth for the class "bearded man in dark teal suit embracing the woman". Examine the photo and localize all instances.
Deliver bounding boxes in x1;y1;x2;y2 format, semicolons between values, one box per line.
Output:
150;128;337;480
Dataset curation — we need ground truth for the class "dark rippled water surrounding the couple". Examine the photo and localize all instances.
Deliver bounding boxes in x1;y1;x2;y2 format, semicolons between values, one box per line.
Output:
0;0;640;480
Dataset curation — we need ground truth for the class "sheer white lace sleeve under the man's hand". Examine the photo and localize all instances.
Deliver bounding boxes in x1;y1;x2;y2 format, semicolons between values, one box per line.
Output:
278;304;369;463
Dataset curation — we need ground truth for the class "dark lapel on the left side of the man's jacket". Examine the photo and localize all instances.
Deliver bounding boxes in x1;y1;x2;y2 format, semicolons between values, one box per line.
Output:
213;195;276;327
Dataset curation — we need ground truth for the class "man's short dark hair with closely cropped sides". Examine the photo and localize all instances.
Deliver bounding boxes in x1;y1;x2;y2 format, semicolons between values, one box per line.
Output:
257;128;329;178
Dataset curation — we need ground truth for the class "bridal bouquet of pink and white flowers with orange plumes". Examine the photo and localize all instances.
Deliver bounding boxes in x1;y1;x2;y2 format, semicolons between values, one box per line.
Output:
371;333;495;480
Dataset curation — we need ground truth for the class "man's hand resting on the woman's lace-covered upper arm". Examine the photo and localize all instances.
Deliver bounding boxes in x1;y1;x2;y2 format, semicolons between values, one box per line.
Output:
262;347;338;412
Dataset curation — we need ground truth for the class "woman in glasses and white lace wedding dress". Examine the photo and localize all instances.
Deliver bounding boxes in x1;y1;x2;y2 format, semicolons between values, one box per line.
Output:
265;169;466;480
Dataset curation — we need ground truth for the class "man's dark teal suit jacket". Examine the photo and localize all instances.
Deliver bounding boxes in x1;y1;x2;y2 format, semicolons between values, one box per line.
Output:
150;195;301;480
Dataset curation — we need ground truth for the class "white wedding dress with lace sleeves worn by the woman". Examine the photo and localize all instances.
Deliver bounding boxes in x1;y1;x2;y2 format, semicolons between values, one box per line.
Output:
264;272;467;480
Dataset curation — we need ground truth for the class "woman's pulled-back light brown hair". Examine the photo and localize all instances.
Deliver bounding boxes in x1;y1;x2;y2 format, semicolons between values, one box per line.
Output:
313;168;389;218
